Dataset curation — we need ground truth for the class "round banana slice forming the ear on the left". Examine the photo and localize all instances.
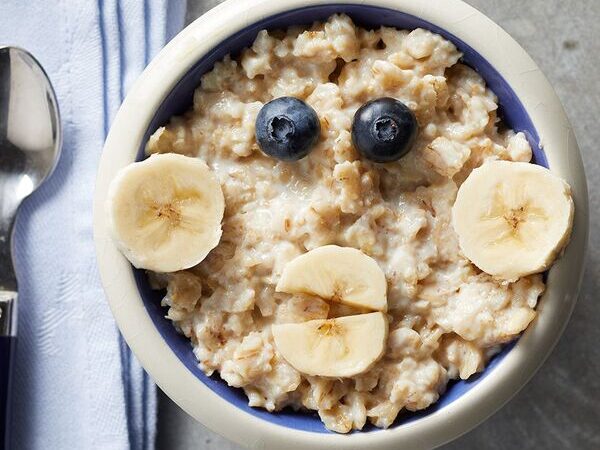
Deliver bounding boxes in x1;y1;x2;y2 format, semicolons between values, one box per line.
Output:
107;153;225;272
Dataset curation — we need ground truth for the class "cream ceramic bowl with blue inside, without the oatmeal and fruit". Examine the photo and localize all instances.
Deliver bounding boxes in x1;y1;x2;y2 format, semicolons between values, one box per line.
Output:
94;0;588;449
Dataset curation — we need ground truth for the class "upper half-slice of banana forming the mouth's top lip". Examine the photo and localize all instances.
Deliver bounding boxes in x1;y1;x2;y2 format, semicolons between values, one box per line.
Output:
276;245;387;311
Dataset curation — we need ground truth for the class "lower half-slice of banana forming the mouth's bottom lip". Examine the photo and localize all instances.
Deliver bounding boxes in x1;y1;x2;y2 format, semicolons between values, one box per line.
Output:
271;312;388;378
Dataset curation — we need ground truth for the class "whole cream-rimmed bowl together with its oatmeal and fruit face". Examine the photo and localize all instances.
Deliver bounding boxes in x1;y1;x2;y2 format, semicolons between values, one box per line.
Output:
94;0;588;449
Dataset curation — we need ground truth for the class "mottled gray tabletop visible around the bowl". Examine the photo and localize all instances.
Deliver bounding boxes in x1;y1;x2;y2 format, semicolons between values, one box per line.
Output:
157;0;600;450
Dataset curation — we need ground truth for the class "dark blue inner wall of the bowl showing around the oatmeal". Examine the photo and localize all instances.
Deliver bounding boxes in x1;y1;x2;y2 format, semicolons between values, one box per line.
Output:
132;4;548;433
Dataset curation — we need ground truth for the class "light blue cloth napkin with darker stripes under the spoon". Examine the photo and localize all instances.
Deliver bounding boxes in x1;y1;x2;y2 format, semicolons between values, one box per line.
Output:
0;0;185;450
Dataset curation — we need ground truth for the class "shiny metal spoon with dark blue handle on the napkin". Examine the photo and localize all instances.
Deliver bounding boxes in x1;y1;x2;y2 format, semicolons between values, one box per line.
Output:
0;47;62;448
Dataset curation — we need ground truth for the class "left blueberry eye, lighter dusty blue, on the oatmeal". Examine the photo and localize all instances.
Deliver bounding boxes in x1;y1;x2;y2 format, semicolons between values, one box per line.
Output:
255;97;321;161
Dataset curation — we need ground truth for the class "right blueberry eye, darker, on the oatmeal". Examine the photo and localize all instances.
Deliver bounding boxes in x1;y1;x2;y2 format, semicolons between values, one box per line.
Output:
352;97;418;162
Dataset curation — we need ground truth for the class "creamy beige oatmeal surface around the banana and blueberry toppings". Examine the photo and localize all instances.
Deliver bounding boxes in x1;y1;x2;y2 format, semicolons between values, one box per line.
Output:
147;15;544;433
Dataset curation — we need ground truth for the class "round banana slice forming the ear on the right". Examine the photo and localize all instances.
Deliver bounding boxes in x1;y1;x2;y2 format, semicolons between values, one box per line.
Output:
452;161;574;281
